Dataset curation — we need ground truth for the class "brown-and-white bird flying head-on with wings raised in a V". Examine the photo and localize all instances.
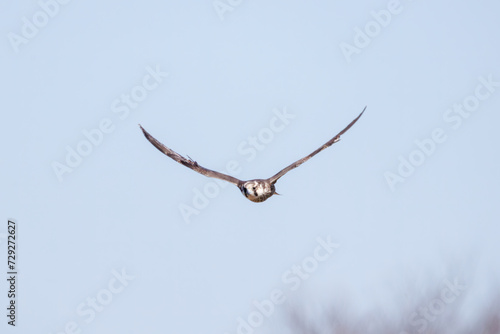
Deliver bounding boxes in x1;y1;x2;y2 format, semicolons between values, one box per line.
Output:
139;107;366;202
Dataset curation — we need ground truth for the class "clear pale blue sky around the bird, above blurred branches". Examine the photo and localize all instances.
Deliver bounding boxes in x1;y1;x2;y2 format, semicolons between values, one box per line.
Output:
0;0;500;333
